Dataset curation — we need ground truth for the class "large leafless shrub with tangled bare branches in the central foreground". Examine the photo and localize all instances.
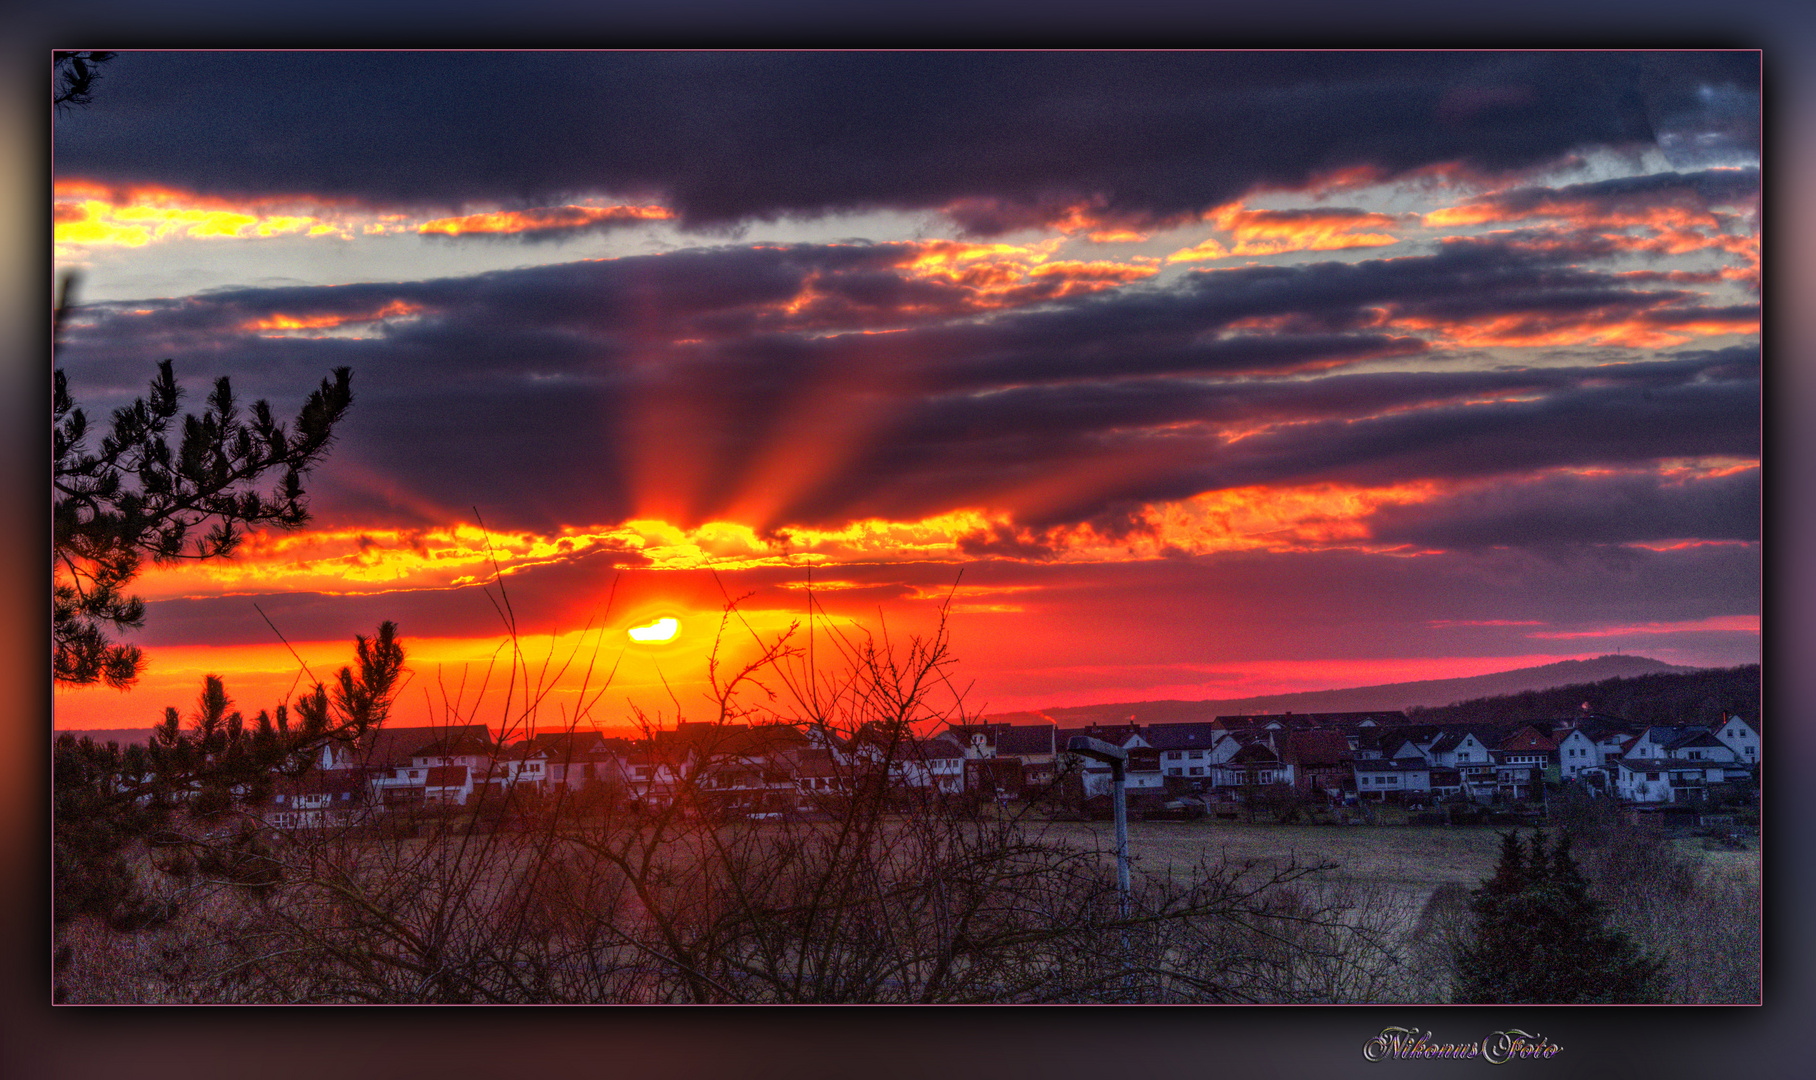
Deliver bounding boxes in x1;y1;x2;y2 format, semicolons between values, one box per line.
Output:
60;591;1445;1004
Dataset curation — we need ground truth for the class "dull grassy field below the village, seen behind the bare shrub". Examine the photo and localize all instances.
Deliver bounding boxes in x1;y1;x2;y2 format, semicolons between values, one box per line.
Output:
65;815;1760;1002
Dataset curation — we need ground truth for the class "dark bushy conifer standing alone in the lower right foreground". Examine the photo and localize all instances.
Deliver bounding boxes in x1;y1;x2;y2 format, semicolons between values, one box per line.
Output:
1451;831;1665;1004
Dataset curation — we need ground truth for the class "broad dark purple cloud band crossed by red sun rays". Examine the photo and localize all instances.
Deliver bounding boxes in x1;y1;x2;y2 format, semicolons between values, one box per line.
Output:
64;232;1760;528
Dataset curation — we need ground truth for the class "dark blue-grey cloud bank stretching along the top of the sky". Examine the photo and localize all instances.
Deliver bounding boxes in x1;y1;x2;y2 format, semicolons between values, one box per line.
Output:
56;51;1758;232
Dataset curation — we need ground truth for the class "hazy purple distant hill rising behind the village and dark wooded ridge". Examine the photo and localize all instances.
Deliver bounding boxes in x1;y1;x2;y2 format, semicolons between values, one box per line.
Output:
988;655;1698;728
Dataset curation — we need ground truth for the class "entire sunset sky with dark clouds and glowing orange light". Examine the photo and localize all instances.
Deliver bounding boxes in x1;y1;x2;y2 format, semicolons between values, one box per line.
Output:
54;53;1760;728
